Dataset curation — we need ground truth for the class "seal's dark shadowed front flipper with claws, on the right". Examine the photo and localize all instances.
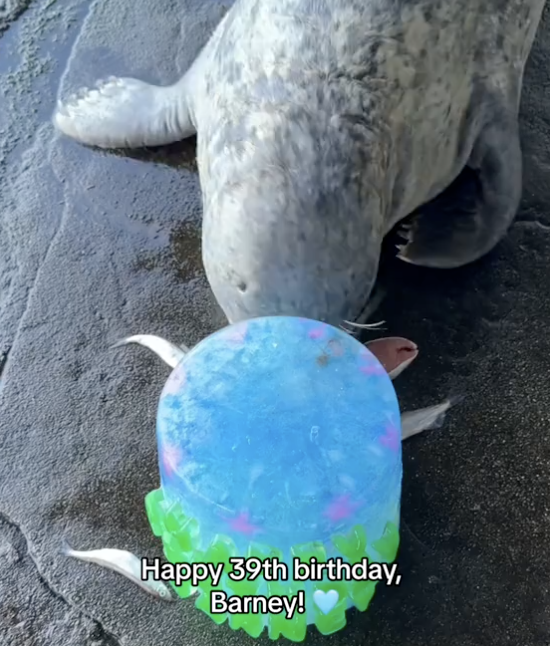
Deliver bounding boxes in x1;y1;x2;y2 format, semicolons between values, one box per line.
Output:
398;115;522;269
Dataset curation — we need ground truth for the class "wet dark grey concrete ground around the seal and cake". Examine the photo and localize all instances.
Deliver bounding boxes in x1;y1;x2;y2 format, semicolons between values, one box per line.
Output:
0;0;550;646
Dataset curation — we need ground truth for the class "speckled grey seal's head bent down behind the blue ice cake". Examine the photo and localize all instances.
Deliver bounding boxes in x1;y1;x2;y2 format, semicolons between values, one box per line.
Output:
202;109;384;325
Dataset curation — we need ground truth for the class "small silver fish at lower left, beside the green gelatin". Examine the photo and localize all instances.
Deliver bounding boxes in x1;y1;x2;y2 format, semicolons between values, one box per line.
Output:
62;541;175;601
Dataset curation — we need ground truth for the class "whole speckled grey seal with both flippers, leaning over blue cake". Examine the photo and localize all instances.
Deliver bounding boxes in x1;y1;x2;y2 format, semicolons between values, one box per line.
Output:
54;0;544;325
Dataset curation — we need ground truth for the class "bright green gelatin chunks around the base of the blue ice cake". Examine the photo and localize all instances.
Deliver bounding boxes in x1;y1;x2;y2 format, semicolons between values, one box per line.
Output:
145;489;399;642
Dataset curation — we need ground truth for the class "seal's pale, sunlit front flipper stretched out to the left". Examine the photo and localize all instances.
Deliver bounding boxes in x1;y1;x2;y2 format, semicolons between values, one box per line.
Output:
53;77;195;148
